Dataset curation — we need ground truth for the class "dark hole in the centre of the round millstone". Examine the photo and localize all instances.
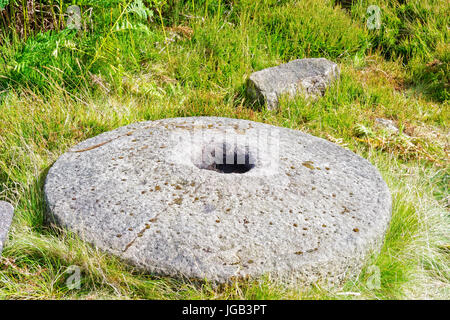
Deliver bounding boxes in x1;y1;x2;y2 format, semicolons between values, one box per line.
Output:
196;142;255;173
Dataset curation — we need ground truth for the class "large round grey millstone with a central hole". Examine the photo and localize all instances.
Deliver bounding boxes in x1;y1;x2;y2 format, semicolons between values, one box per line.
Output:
45;117;391;283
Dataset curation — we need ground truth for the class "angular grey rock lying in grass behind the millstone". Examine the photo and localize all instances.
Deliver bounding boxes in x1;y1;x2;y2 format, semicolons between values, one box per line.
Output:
247;58;340;109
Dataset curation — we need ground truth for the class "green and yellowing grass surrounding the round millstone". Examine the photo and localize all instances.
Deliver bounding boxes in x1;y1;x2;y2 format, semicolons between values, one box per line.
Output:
0;0;450;299
